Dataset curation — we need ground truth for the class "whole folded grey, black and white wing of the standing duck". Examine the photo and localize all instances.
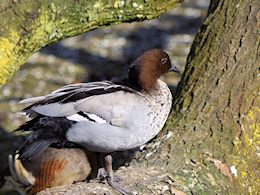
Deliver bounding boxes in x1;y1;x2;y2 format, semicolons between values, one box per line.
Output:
21;81;140;125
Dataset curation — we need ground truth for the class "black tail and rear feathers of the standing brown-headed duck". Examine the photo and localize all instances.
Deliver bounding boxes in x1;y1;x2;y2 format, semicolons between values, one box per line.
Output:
15;116;75;160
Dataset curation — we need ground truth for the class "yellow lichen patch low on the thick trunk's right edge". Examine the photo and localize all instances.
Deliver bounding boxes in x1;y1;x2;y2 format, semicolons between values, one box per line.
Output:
230;107;260;194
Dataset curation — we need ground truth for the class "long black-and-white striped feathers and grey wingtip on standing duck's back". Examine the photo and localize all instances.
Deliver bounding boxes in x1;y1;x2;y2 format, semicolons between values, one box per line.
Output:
22;81;137;117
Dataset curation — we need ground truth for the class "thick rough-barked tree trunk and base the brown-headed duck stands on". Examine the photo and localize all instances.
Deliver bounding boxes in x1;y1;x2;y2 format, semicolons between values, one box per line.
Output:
37;0;260;194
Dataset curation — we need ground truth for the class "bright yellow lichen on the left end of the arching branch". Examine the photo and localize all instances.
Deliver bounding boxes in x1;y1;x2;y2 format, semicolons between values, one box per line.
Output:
0;6;59;85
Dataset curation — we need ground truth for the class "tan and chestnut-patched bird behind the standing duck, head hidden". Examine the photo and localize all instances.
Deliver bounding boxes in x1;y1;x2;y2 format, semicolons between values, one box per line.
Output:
4;147;93;194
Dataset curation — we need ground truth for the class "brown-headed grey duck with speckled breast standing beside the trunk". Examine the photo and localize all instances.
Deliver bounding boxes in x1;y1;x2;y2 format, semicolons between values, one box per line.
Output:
16;49;179;194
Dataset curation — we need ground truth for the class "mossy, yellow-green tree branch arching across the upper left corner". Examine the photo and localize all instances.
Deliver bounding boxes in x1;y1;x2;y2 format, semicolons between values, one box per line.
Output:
0;0;182;85
